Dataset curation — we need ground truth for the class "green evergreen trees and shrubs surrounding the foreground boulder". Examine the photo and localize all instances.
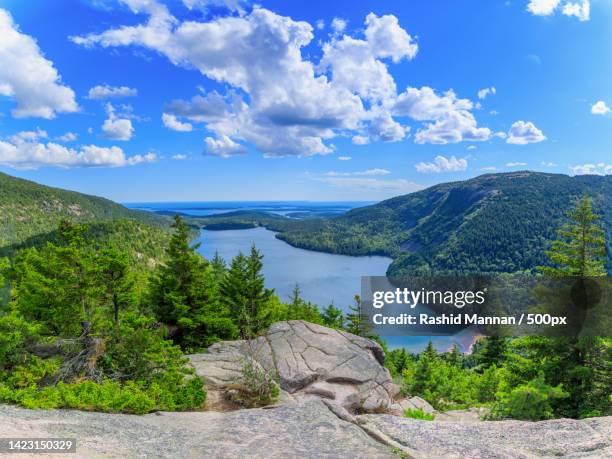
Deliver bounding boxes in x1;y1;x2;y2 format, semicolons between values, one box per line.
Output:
0;176;612;420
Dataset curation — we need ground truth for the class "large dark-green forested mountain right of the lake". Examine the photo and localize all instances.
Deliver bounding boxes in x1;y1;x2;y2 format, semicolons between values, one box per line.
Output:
277;171;612;275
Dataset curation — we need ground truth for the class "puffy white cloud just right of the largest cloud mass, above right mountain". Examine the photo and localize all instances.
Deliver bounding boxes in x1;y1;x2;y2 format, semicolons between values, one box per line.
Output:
393;86;491;144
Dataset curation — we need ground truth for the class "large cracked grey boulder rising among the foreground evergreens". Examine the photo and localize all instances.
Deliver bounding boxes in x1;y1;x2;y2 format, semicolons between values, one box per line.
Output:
189;320;399;412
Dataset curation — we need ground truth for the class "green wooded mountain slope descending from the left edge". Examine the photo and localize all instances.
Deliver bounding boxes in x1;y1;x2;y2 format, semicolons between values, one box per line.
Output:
0;173;168;256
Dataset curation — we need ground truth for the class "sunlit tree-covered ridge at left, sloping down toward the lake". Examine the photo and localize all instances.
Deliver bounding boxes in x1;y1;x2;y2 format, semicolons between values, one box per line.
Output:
0;173;168;253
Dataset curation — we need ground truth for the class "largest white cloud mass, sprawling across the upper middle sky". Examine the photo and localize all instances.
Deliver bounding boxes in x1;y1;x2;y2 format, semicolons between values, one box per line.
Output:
71;0;428;156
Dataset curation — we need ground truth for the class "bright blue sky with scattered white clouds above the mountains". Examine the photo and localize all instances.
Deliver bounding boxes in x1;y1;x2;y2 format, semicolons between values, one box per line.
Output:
0;0;612;202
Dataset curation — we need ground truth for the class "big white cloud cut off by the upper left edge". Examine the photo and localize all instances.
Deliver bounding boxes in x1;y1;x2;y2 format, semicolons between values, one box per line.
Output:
0;8;78;119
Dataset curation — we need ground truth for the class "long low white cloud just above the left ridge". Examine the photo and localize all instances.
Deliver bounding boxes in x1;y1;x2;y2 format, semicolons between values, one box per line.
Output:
0;132;157;169
